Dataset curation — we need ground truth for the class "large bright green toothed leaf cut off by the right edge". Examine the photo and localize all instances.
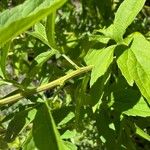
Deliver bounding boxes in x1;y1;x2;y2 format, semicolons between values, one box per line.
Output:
117;33;150;103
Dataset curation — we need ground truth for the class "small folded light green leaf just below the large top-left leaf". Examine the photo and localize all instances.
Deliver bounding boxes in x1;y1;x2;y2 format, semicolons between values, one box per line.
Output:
26;23;50;47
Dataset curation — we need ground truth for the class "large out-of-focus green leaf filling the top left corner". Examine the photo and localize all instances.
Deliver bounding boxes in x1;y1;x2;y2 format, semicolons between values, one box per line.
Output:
0;0;66;45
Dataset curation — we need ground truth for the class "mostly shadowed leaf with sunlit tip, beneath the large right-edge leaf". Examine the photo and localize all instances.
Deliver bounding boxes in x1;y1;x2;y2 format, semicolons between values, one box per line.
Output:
110;79;150;117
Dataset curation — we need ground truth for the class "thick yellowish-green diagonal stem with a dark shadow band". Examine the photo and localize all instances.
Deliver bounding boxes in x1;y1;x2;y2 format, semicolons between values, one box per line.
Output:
0;65;93;106
